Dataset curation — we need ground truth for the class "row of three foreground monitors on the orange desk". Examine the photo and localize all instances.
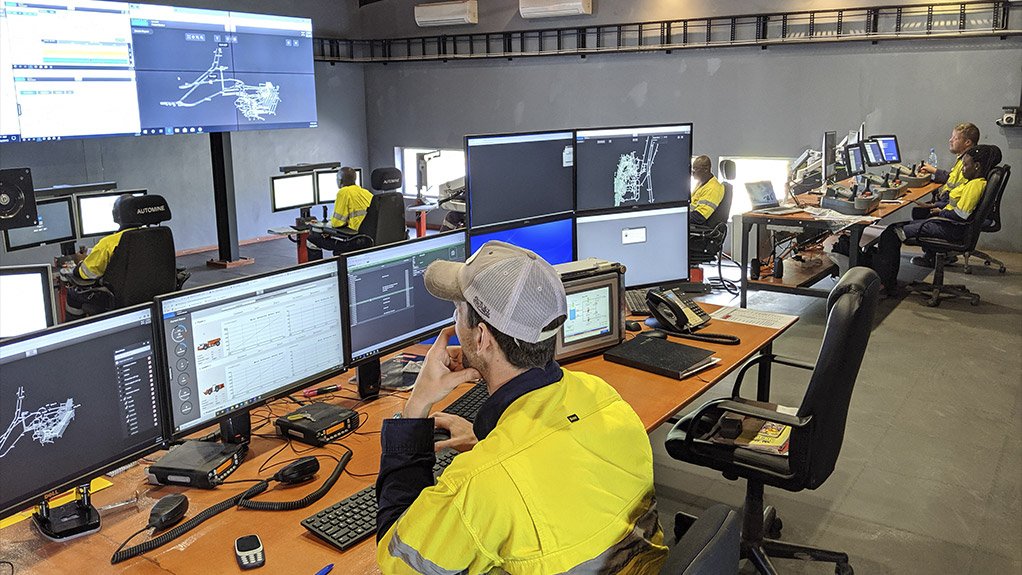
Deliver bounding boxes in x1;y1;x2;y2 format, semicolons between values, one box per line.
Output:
0;231;478;538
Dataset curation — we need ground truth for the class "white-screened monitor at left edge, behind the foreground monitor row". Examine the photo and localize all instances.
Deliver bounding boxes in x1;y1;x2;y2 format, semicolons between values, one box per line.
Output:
0;263;56;341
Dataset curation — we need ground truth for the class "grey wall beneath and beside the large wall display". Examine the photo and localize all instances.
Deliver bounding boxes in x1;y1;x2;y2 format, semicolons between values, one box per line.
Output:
0;63;368;266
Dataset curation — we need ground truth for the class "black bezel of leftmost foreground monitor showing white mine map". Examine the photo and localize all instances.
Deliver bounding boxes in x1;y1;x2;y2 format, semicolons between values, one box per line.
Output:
0;303;169;519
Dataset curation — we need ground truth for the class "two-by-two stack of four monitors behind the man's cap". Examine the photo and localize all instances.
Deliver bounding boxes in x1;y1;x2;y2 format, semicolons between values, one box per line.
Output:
465;124;692;287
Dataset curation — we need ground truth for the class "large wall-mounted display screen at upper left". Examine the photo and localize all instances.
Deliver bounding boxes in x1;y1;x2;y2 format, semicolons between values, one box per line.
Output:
0;0;317;142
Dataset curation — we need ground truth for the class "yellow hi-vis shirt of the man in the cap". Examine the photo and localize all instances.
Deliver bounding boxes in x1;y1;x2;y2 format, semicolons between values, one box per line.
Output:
377;370;667;575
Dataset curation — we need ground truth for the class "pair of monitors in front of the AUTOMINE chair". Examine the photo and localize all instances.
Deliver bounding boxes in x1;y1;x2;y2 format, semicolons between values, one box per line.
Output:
3;182;146;254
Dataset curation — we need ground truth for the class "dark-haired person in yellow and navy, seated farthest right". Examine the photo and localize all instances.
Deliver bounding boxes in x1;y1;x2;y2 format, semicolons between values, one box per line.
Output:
877;146;993;285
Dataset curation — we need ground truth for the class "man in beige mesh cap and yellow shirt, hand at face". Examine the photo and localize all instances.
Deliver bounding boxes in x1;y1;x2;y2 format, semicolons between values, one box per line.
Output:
376;241;666;575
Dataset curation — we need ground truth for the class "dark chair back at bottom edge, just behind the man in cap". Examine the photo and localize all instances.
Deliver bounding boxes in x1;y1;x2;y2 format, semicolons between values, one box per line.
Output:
660;504;742;575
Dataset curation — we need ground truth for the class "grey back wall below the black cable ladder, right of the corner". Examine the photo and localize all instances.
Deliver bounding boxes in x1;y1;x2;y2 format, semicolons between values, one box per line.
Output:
366;37;1022;251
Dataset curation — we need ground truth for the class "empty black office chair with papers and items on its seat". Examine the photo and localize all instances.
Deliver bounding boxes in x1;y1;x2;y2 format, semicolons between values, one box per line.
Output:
666;267;880;575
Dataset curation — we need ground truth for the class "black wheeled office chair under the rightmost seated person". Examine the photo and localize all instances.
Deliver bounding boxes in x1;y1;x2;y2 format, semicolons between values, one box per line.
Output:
904;161;1012;307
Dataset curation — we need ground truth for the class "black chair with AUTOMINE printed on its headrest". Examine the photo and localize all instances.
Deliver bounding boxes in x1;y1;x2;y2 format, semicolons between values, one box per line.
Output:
72;194;180;316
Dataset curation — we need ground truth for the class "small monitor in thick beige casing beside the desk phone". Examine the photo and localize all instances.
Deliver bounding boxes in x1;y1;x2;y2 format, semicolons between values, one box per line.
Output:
554;272;624;362
